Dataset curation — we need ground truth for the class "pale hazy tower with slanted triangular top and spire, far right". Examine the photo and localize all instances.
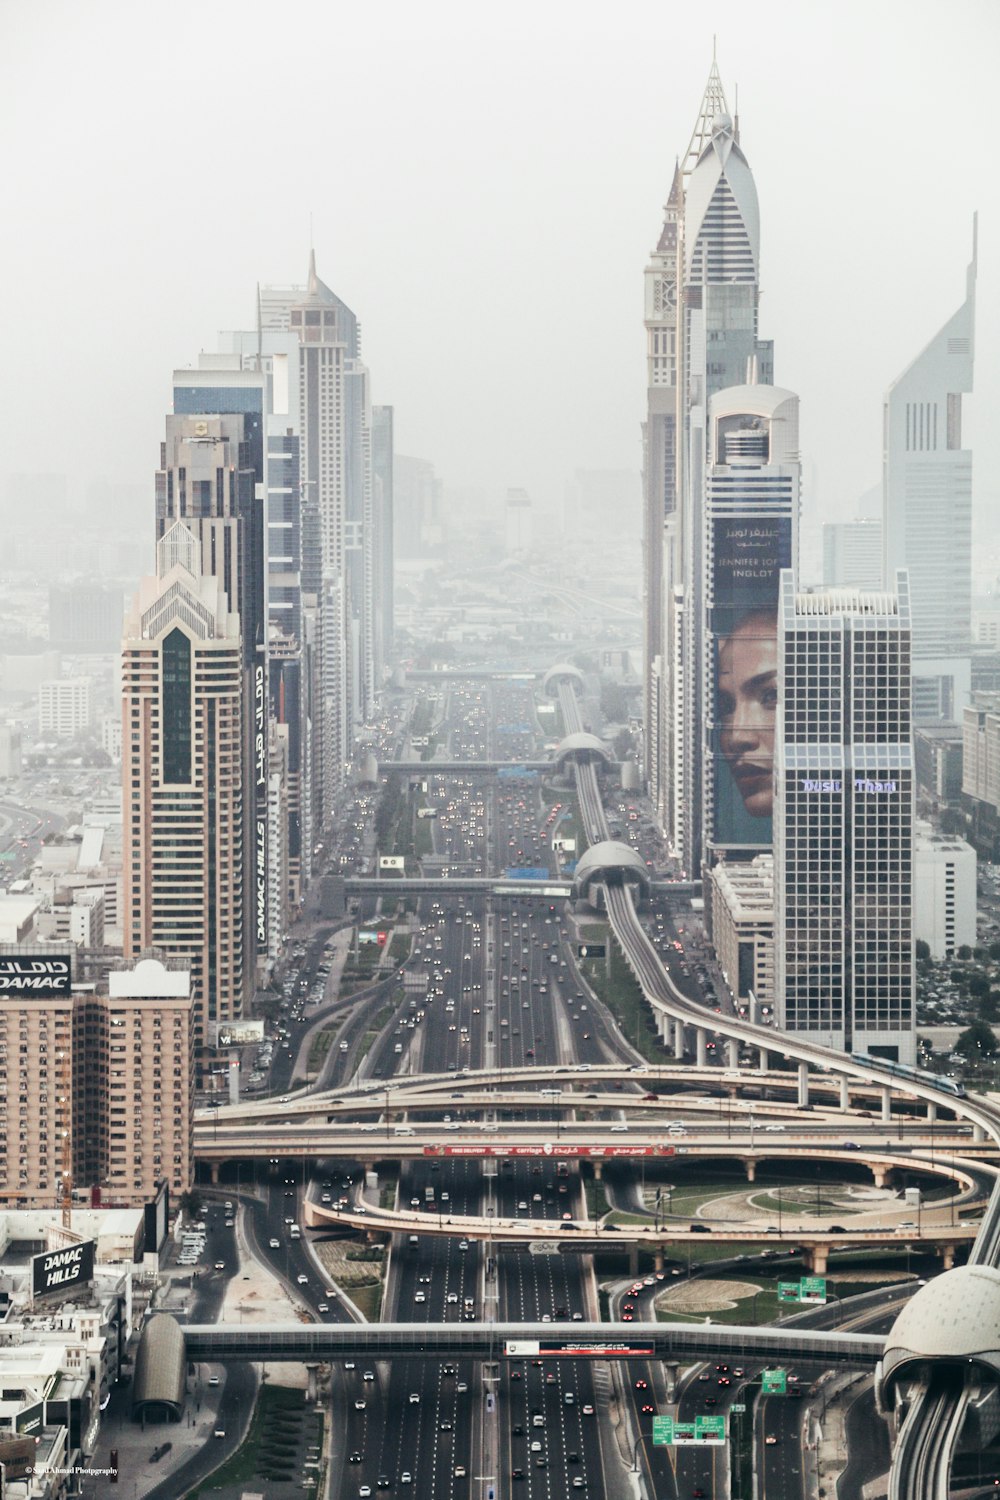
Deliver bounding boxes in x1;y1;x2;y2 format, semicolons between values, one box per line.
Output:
883;227;976;723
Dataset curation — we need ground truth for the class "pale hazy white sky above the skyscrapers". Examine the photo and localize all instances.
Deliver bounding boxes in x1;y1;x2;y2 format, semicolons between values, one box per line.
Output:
0;0;1000;530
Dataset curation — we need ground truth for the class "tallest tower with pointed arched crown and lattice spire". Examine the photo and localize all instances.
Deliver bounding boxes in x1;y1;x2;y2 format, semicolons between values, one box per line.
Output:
643;62;774;870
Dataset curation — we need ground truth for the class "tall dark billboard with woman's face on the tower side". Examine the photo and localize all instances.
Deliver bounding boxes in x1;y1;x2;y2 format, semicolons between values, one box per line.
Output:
709;516;792;848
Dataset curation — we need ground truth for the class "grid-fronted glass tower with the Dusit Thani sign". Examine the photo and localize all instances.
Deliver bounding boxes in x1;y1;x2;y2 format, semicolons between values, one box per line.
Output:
774;570;916;1064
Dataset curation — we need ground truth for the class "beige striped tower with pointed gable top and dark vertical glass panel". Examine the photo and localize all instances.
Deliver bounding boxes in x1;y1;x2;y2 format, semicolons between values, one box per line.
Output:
121;522;245;1053
